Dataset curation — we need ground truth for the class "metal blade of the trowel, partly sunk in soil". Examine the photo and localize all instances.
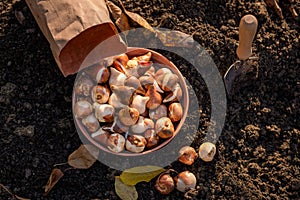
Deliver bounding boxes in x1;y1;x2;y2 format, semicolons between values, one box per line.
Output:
224;61;243;96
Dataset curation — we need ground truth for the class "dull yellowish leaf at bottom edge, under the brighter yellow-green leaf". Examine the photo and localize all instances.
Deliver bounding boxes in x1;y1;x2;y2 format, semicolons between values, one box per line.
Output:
115;176;138;200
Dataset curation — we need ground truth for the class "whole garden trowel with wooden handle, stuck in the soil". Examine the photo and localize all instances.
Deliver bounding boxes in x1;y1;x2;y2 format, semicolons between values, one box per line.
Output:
224;14;258;96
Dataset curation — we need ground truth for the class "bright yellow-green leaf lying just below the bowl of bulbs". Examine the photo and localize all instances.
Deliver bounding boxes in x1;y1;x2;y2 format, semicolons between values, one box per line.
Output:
120;165;165;185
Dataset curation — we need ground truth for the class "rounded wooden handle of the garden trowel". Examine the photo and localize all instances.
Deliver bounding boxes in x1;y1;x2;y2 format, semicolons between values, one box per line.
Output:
236;15;257;60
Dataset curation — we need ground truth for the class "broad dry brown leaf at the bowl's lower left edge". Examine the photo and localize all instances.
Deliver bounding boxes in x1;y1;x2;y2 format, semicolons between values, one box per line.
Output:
68;144;99;169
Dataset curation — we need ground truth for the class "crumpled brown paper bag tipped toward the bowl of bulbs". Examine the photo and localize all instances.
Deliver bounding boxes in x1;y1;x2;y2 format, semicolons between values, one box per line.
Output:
26;0;126;76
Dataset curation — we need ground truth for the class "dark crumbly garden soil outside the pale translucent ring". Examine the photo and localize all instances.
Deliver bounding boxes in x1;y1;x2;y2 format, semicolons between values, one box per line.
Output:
0;0;300;199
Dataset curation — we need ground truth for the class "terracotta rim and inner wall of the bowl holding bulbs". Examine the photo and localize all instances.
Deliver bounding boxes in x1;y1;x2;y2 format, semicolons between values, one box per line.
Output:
73;47;189;156
